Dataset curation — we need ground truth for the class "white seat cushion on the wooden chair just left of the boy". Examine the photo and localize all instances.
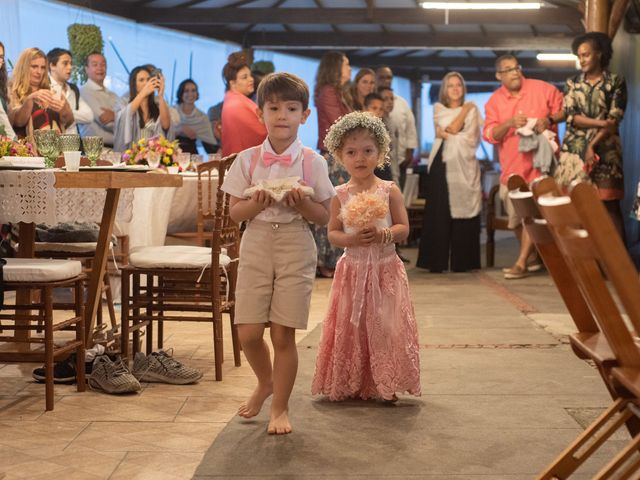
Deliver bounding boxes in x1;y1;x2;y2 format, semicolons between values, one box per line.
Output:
129;245;231;268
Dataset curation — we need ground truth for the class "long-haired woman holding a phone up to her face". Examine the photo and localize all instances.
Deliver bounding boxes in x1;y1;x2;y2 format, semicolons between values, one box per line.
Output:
113;65;174;152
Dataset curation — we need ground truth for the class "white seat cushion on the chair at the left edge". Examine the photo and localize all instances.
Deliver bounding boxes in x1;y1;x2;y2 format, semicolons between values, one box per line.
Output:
3;258;82;283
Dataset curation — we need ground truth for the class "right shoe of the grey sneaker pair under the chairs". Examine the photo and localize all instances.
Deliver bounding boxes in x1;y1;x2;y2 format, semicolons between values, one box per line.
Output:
133;350;202;385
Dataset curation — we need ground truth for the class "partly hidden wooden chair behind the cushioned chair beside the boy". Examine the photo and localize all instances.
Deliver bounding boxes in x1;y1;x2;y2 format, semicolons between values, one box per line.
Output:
171;162;222;247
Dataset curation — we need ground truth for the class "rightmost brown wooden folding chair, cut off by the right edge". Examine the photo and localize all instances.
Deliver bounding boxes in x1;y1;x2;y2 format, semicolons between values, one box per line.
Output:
538;184;640;479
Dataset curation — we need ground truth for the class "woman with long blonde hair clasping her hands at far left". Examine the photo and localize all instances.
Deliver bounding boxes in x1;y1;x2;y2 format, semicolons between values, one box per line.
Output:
8;48;73;139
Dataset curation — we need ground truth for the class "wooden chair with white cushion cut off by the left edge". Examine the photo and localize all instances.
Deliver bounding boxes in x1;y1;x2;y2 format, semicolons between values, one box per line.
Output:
0;258;86;410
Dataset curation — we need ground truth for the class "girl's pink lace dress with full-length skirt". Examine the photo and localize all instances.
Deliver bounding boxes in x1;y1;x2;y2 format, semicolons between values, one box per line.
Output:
311;182;421;400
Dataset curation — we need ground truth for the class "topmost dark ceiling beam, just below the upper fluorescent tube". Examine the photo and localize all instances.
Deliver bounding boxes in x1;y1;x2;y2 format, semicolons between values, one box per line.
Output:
136;6;582;28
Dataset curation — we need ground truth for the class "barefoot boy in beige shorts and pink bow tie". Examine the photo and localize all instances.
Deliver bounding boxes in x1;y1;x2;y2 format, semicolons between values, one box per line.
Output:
222;73;335;434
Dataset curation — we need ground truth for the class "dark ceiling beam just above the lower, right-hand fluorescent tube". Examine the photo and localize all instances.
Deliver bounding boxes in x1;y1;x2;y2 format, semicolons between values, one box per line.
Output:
238;29;572;51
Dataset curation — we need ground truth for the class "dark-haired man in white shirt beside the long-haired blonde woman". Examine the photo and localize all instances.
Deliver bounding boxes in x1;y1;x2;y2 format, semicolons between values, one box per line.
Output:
47;48;93;134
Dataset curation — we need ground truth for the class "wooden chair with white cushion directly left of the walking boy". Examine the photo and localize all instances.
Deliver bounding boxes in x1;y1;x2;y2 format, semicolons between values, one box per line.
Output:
121;154;240;381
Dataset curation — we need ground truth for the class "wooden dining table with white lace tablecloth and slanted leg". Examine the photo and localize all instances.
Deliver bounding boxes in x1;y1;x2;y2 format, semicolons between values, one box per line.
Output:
0;168;183;361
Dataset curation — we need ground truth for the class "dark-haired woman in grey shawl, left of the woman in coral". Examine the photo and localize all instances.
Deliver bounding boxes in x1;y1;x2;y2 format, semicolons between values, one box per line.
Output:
175;78;217;153
